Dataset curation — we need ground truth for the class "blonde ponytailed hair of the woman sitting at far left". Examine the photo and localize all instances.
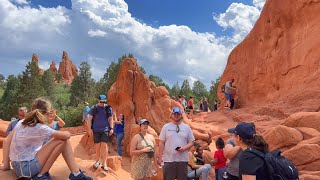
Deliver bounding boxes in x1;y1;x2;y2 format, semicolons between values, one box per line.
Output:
22;98;52;127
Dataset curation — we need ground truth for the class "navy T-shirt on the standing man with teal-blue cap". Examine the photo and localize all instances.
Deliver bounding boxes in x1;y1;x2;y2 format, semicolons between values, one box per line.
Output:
89;105;112;132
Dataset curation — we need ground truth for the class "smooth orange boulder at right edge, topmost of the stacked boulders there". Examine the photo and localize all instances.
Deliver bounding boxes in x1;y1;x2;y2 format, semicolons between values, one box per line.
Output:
282;112;320;131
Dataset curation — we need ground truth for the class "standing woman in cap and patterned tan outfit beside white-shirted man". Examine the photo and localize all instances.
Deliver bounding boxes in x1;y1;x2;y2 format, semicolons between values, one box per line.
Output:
130;119;157;180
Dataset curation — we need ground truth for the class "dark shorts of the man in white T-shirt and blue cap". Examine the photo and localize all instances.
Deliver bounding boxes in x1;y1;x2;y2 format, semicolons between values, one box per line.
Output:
163;162;188;180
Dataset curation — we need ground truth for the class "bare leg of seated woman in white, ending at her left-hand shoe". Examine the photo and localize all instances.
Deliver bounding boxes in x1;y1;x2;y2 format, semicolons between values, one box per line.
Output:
36;139;66;174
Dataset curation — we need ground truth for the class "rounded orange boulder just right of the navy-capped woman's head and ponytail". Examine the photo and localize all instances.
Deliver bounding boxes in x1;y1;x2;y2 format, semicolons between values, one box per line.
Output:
263;125;303;151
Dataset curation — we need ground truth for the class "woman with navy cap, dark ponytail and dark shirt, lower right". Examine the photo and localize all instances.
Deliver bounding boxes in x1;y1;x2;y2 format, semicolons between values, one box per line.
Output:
228;122;269;180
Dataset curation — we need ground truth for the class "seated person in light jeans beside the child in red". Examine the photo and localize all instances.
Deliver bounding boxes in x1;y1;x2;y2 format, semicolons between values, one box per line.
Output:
188;142;211;180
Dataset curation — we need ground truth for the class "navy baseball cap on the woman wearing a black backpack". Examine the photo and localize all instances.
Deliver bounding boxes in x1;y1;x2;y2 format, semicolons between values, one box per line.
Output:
228;122;256;139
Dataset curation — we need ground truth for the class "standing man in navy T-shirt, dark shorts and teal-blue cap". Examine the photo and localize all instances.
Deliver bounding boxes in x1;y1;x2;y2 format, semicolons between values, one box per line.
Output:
88;94;114;171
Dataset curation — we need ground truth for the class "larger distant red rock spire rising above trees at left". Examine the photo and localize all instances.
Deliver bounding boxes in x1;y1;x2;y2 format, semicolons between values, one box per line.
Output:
58;51;78;84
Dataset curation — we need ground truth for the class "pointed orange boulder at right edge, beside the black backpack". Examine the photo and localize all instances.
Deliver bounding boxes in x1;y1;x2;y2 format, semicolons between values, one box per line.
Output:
282;144;320;166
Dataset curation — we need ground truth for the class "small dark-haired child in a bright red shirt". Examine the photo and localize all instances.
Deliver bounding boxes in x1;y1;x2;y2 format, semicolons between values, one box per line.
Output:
212;137;227;180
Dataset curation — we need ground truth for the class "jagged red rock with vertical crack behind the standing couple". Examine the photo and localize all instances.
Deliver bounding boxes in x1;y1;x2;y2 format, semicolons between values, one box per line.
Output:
108;58;211;155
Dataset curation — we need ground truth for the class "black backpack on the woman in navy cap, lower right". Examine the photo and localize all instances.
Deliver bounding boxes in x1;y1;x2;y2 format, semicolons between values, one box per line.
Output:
250;149;299;180
